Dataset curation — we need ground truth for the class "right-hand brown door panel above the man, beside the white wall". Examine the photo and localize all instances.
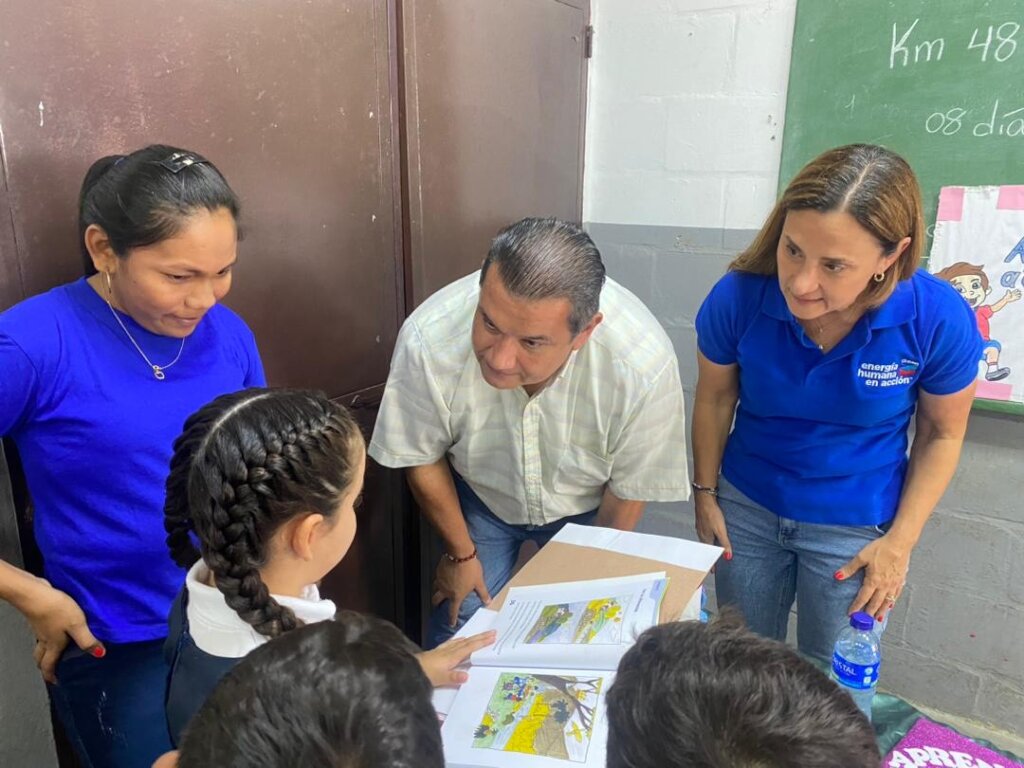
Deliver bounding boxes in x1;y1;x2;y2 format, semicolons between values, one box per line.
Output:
399;0;590;309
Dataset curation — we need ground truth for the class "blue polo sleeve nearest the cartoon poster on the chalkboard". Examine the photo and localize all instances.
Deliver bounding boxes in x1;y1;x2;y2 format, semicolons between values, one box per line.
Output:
918;287;983;394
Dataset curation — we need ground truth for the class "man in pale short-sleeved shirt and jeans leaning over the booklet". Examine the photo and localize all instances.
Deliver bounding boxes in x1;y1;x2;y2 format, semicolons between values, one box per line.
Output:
370;219;689;647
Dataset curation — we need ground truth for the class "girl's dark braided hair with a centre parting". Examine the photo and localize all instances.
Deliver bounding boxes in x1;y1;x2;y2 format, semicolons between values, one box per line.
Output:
164;388;362;638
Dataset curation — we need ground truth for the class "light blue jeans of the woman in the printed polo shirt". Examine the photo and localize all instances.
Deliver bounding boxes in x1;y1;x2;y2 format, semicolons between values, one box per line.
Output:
715;477;885;663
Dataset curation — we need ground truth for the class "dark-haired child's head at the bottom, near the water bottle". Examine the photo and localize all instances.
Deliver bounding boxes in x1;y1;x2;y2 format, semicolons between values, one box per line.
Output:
606;614;882;768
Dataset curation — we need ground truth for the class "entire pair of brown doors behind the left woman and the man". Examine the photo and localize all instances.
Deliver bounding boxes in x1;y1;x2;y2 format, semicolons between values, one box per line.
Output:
0;0;589;651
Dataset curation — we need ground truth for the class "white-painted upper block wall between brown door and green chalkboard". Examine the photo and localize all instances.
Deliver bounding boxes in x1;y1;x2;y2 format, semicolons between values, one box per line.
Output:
584;0;797;229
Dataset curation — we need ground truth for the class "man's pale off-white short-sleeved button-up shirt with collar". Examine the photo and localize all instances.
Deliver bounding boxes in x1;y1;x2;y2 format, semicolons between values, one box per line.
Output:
370;271;689;525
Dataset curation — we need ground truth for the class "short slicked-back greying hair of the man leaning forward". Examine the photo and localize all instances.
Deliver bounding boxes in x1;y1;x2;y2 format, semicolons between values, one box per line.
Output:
480;218;604;336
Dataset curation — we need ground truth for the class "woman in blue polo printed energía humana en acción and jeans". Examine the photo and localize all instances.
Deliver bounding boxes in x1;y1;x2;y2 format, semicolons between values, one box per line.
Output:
693;144;981;659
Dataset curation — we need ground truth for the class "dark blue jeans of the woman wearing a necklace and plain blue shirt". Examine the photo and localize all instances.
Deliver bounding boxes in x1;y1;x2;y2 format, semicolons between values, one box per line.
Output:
47;640;171;768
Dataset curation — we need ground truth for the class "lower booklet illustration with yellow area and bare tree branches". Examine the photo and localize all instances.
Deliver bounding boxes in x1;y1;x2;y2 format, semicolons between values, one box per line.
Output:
473;673;604;763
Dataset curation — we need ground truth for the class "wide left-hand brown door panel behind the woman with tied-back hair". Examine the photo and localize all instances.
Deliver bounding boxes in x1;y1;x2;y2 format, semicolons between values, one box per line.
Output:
0;0;401;396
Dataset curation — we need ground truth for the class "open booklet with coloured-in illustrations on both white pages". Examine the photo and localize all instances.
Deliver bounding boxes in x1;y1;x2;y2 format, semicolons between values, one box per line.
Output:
442;572;668;768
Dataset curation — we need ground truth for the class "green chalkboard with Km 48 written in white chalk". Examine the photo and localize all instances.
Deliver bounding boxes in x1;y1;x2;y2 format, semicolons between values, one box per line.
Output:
779;0;1024;414
